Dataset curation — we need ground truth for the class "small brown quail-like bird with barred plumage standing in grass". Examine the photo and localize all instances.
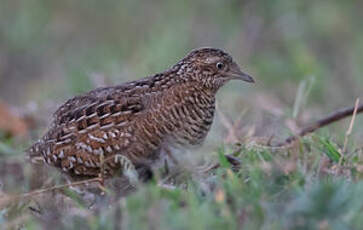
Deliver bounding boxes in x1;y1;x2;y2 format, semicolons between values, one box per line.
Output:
28;48;254;177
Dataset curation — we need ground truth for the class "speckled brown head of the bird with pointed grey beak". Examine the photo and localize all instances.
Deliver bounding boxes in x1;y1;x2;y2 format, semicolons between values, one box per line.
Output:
181;48;255;90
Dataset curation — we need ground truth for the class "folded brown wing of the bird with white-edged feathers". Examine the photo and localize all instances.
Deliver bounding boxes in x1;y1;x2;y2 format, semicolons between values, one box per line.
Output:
29;88;145;176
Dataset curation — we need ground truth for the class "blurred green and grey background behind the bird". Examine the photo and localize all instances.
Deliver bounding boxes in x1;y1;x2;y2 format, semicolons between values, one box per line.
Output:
0;0;363;143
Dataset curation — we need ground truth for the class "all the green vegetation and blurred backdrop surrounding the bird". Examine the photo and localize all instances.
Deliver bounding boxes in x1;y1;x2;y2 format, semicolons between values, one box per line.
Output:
0;0;363;230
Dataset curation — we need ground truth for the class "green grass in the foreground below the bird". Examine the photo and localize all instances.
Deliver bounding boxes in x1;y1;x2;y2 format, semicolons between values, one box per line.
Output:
0;135;363;229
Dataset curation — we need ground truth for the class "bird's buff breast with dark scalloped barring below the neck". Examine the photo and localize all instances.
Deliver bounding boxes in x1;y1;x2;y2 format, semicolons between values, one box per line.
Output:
148;86;215;147
